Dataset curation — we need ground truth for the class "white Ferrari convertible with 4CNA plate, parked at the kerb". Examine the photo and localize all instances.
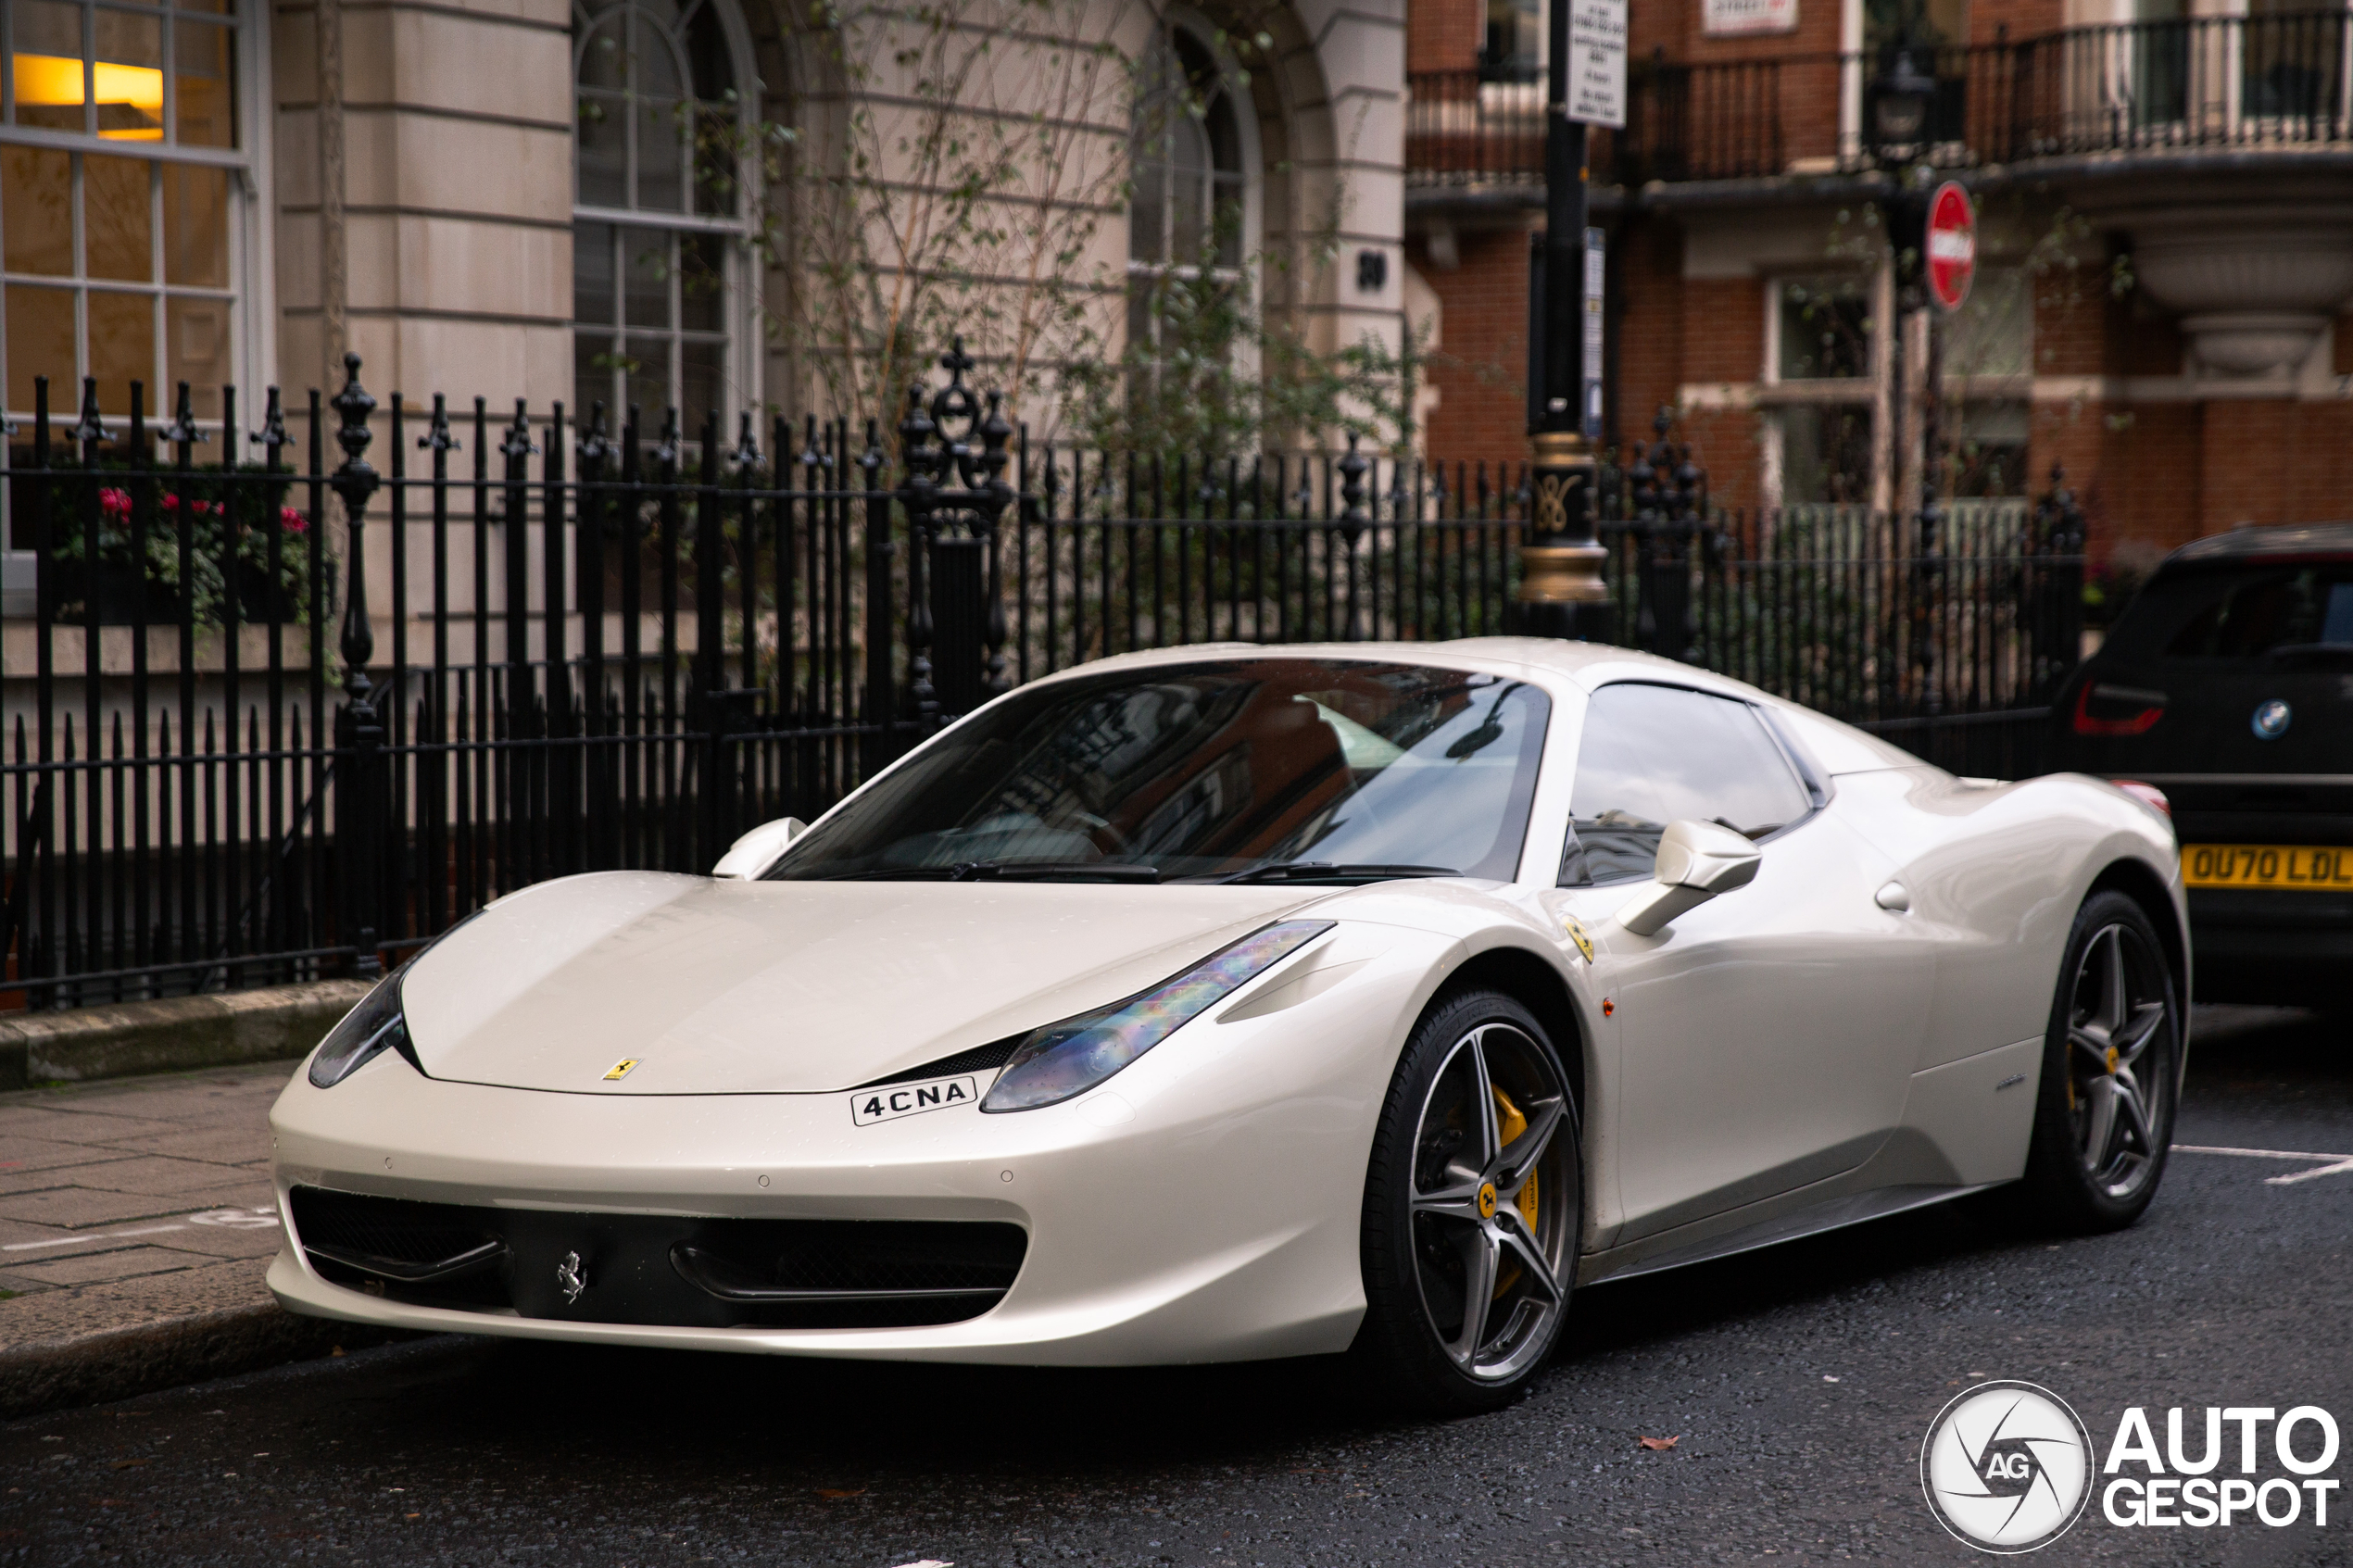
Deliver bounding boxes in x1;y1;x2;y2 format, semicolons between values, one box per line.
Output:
269;637;2188;1411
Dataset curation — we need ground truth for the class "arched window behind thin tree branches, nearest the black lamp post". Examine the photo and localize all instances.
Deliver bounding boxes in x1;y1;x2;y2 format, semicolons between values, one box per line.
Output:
1127;17;1259;364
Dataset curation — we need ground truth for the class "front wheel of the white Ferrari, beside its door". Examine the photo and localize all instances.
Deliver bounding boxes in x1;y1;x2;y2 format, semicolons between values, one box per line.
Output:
1355;990;1583;1415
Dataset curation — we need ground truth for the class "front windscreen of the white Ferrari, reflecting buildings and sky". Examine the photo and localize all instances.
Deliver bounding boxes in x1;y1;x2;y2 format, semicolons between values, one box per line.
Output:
770;659;1551;882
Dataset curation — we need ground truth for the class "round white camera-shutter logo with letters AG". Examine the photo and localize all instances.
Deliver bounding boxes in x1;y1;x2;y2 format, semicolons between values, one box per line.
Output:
1920;1380;2092;1554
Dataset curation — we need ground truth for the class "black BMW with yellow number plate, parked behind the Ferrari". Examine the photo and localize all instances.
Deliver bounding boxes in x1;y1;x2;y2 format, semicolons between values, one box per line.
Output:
2052;521;2353;1009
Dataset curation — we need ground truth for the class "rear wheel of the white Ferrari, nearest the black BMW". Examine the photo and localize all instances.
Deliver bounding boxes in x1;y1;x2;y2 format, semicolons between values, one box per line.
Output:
2019;894;2182;1232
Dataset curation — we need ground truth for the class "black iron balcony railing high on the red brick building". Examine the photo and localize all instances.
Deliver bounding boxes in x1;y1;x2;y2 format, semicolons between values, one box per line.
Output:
1404;9;2353;191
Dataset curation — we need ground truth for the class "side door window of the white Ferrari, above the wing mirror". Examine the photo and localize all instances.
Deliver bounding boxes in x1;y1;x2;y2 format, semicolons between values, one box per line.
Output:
1560;682;1812;886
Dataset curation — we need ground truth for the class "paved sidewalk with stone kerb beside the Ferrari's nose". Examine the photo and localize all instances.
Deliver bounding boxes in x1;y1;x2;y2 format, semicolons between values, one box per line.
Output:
0;1062;365;1415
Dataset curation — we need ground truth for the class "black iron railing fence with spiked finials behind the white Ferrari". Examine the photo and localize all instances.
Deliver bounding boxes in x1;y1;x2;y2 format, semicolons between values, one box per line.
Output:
0;353;2080;1006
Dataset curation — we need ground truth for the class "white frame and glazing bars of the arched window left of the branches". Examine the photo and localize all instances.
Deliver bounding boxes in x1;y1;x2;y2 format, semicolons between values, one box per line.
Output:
567;0;762;442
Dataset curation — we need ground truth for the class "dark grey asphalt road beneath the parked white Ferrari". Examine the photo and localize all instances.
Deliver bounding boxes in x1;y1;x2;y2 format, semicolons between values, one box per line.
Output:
0;1016;2353;1568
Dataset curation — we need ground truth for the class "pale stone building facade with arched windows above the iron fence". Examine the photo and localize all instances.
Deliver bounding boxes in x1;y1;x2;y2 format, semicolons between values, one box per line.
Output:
0;0;1404;608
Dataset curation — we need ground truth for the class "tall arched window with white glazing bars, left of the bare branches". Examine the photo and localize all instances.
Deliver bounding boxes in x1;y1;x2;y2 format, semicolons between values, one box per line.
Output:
572;0;758;433
